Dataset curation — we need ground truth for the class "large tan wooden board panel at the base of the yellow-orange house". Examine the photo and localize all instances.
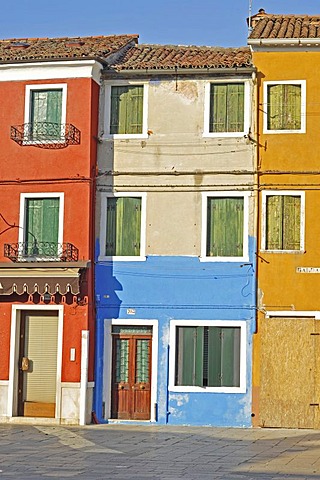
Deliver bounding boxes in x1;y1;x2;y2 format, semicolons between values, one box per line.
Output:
259;317;320;428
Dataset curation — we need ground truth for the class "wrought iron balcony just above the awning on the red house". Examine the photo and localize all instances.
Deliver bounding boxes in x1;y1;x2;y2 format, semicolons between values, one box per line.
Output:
4;242;79;262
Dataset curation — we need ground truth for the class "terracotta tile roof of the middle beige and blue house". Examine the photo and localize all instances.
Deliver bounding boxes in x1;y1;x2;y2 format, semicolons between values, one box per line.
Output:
106;44;252;71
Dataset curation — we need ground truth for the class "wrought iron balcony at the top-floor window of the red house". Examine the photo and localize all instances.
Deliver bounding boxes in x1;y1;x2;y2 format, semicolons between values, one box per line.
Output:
10;122;80;149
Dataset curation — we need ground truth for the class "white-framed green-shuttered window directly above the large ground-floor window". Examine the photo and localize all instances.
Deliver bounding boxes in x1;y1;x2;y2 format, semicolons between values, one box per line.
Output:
201;192;248;261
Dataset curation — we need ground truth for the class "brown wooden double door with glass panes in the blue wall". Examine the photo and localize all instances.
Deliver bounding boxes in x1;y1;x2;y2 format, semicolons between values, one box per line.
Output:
111;327;152;420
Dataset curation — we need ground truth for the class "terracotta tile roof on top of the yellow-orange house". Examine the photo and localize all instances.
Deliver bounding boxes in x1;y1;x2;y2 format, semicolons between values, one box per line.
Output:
249;9;320;40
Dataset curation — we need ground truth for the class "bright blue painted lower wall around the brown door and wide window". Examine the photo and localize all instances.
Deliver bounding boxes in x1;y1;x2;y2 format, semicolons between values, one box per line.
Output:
94;239;256;427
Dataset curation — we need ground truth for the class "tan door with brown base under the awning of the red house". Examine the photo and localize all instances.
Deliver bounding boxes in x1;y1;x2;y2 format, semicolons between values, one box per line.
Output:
18;312;58;417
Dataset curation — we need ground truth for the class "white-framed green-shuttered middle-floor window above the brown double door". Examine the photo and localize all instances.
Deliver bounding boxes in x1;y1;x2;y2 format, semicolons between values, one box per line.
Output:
101;193;145;260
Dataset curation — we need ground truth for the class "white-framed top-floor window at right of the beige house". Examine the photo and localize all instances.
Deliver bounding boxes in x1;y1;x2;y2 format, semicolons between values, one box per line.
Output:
204;81;250;136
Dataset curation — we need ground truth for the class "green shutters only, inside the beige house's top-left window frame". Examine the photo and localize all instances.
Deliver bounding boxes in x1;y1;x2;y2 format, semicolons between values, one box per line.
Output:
110;85;143;134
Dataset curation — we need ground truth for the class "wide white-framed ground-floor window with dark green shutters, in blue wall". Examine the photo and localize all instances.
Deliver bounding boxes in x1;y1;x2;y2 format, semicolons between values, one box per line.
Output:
171;321;245;391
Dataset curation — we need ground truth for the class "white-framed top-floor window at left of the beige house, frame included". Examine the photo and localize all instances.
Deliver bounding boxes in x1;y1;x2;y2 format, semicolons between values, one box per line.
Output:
106;84;148;138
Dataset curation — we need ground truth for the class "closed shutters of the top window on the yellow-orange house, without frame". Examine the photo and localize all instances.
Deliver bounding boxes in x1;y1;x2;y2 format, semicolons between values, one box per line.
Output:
267;84;301;130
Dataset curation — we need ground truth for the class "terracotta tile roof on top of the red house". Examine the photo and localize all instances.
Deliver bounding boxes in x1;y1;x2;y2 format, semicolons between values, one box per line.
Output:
0;35;138;63
